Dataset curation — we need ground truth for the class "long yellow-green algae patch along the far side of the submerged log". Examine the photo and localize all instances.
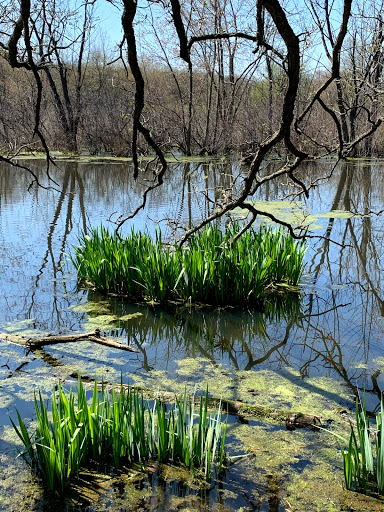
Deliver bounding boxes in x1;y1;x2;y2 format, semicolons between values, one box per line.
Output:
134;357;354;421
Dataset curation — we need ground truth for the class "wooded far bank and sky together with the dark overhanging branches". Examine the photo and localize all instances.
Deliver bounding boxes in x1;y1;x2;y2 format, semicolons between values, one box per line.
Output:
0;0;384;234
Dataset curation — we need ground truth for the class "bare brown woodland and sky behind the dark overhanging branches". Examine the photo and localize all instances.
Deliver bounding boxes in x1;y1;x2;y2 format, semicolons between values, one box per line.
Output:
0;0;384;155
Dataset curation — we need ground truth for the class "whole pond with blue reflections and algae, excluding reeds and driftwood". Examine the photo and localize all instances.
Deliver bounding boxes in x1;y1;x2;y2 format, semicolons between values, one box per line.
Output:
0;159;384;511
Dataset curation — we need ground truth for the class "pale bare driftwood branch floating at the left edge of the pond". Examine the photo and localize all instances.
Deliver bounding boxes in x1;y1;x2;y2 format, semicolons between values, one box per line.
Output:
0;329;139;352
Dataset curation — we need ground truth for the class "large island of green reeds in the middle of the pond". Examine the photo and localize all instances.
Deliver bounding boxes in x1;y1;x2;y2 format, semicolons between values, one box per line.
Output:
72;224;306;305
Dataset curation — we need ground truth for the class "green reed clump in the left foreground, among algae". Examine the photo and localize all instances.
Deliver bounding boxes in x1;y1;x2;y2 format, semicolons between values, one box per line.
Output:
11;379;226;493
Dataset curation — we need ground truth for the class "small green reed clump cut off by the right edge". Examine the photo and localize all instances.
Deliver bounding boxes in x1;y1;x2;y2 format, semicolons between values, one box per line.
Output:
337;397;384;495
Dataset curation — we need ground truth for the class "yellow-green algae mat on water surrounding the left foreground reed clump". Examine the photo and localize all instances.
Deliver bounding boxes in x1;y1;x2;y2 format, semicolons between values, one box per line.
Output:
0;334;383;512
